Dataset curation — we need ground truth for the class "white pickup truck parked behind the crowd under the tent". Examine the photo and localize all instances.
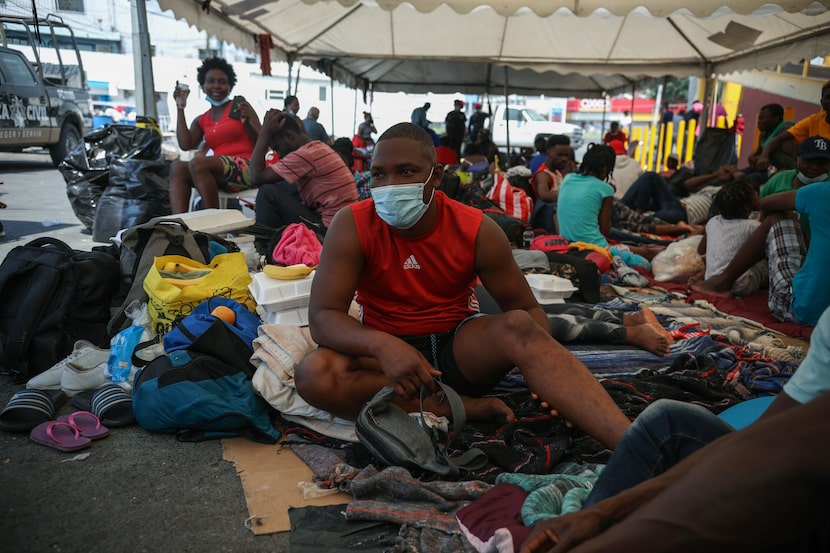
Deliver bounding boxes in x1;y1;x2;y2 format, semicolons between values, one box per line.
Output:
488;105;585;150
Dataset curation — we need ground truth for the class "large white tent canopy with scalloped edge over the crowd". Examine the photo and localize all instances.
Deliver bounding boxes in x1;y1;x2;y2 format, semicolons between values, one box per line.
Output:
159;0;830;96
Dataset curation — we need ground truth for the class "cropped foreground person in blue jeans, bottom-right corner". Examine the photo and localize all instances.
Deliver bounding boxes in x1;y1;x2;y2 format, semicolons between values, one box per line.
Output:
521;302;830;553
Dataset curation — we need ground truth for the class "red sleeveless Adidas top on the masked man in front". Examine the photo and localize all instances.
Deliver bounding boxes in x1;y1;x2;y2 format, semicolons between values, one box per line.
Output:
349;190;483;335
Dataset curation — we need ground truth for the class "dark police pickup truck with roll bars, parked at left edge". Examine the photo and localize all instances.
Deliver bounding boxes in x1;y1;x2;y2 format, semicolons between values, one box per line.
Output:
0;16;92;165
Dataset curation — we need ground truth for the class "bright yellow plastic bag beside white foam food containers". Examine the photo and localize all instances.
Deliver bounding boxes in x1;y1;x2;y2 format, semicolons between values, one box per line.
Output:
144;252;256;335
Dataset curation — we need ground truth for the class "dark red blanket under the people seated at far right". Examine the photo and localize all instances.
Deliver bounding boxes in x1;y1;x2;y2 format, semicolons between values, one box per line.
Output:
640;269;813;341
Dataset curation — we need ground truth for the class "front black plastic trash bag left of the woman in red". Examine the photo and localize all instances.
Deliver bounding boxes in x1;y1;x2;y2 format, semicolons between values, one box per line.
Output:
92;158;170;242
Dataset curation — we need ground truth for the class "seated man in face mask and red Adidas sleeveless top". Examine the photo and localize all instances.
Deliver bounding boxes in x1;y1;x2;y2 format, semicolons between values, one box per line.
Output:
295;123;630;448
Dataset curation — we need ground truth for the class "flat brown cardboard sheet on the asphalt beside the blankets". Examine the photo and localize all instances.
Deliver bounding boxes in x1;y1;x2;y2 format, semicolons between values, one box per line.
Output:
222;438;352;535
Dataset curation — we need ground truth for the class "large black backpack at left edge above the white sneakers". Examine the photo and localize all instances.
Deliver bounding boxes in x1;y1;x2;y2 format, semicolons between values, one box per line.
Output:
0;237;119;382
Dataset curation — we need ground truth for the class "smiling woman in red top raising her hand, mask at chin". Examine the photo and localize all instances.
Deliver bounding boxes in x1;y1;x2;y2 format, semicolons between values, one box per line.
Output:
170;58;261;213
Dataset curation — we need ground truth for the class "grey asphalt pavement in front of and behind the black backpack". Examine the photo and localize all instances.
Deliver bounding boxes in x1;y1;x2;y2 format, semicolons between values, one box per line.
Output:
0;153;289;553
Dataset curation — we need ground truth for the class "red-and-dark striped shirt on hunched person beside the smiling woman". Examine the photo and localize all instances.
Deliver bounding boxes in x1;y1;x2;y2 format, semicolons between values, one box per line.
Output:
271;140;358;227
